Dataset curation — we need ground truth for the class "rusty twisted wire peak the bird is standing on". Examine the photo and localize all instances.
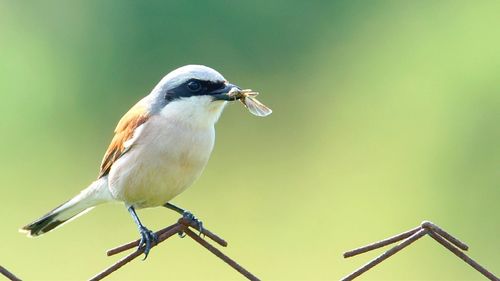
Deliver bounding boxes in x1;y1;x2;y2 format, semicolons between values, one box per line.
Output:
89;217;260;281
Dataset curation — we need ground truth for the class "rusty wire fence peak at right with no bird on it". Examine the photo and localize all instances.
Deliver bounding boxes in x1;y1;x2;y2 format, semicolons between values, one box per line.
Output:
341;221;500;281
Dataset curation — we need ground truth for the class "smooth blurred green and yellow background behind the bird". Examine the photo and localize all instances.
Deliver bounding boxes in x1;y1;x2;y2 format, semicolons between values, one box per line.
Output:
0;0;500;280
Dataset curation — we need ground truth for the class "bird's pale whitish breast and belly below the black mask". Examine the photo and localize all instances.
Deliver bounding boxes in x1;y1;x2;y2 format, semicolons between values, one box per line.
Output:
109;97;229;208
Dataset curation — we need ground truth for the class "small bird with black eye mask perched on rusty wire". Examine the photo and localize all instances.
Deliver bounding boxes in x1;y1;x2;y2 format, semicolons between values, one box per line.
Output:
20;65;240;259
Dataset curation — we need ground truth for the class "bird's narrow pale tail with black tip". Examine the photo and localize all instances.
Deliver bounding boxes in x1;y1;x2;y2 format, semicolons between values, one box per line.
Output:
19;177;112;237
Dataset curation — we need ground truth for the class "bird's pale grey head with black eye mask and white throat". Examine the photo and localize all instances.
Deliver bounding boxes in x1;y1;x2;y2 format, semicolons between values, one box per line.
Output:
147;65;238;124
